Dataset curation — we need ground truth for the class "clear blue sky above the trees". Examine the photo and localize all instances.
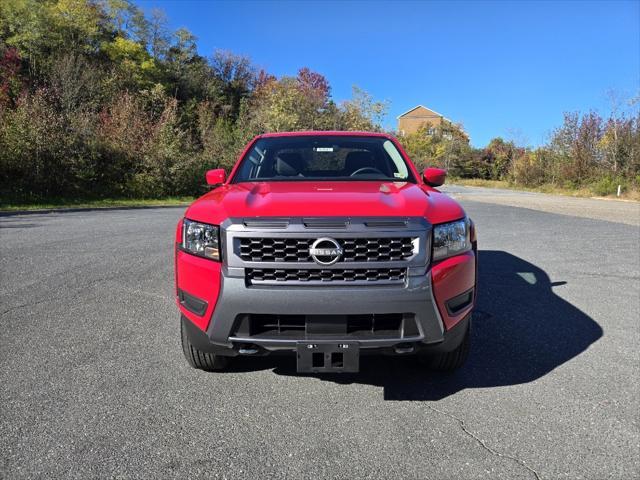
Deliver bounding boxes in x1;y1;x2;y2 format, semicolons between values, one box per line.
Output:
138;0;640;146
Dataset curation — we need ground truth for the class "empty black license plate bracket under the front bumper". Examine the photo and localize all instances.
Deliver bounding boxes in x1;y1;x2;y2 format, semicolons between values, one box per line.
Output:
297;341;360;373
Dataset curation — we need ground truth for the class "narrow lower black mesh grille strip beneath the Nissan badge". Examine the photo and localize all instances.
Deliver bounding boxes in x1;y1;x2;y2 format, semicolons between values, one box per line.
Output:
246;268;407;283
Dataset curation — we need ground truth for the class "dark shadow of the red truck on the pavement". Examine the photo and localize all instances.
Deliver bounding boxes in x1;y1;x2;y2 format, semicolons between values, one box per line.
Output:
230;250;602;400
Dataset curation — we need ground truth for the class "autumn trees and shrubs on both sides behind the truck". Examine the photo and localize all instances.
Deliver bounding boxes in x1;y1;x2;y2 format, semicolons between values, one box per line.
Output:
0;0;640;202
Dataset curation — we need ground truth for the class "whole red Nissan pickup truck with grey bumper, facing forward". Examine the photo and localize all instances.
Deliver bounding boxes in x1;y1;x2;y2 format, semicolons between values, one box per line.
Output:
175;132;477;372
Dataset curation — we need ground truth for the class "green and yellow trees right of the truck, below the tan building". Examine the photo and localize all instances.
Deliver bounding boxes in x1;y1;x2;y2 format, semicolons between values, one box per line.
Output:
401;104;640;195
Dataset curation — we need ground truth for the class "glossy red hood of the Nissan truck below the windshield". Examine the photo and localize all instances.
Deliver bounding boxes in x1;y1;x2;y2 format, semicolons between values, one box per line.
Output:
186;181;464;224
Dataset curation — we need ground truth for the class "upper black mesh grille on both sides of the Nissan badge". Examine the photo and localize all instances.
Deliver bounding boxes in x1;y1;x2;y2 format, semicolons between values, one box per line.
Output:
239;237;413;262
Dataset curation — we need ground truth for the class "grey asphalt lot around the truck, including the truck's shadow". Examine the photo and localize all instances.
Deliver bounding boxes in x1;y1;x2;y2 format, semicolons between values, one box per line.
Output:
0;192;640;479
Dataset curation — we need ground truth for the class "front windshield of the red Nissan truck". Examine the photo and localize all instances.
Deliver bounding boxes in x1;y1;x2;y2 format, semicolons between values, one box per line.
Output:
232;135;415;183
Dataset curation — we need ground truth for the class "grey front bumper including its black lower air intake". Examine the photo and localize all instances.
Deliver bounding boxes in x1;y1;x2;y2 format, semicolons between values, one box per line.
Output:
180;271;469;364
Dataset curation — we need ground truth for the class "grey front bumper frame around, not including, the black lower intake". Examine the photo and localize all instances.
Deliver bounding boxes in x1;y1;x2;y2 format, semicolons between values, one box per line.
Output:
181;262;470;355
